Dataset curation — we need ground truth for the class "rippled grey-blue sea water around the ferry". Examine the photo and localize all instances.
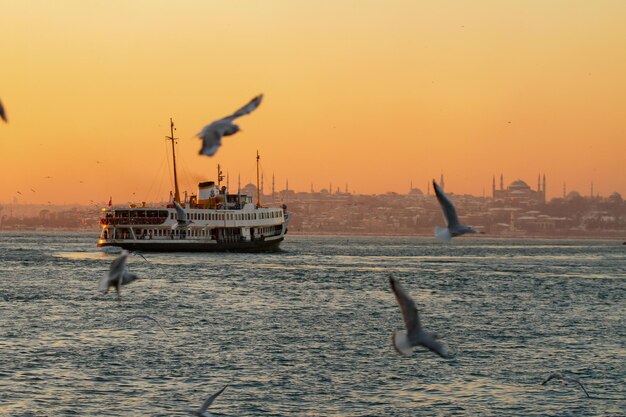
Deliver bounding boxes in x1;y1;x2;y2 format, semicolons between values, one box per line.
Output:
0;233;626;416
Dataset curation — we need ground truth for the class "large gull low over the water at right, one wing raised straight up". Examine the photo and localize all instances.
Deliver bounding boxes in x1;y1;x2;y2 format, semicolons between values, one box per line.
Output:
389;277;451;359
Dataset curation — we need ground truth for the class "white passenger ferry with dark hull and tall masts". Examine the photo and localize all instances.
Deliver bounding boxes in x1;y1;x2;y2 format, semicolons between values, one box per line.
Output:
98;119;289;252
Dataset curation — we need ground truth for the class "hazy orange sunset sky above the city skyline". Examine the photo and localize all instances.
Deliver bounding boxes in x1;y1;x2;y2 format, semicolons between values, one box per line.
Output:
0;0;626;204
